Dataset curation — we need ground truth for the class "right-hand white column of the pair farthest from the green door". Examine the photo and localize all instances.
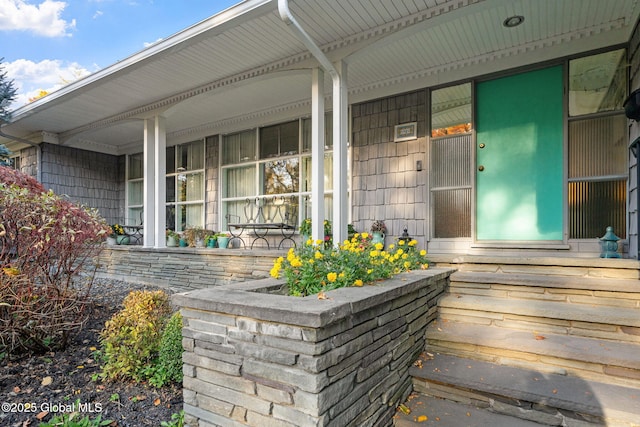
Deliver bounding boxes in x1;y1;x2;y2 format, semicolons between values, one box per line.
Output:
149;116;167;248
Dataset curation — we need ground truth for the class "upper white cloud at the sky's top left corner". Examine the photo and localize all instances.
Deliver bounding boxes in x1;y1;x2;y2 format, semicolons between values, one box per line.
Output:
0;0;76;37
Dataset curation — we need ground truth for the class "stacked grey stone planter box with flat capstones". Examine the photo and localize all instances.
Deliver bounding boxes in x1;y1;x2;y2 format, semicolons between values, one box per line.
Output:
174;268;454;427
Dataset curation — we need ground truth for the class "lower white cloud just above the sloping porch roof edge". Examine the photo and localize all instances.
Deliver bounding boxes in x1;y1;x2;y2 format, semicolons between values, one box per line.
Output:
3;59;91;110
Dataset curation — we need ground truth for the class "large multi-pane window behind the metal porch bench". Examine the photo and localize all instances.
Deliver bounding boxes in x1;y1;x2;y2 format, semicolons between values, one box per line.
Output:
221;119;332;228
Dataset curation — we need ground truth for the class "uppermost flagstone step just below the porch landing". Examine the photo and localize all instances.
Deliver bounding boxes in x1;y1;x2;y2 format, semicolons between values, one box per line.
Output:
450;271;640;308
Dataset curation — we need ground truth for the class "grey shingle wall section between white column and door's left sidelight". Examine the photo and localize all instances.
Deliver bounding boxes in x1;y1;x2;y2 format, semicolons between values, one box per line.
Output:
352;91;428;246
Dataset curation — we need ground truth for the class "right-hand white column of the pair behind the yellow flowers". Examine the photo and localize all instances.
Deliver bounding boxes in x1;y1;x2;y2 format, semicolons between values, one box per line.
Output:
333;61;348;245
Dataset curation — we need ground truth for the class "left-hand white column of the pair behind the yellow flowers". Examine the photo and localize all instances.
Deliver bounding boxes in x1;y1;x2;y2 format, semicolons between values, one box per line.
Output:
311;68;325;240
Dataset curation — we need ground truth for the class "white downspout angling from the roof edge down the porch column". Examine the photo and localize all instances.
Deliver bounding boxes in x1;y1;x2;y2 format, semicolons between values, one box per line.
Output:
278;0;347;244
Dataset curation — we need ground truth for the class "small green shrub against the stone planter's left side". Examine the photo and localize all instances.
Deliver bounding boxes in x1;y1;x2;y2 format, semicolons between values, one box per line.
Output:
149;311;183;387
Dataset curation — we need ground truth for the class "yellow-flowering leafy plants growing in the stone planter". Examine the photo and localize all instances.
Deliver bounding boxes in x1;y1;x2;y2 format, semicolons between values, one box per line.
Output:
271;233;429;296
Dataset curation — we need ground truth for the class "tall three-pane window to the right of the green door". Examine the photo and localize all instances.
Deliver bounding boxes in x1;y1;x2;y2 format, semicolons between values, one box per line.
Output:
568;49;628;239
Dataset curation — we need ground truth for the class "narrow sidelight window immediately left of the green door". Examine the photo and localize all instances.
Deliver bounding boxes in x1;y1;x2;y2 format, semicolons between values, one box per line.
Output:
430;83;473;238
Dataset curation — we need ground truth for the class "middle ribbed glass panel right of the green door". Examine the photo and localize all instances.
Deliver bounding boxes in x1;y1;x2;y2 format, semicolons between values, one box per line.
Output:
569;114;627;178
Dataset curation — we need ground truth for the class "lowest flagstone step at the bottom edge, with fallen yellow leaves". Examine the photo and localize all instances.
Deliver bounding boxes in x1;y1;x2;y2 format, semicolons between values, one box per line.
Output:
393;393;540;427
